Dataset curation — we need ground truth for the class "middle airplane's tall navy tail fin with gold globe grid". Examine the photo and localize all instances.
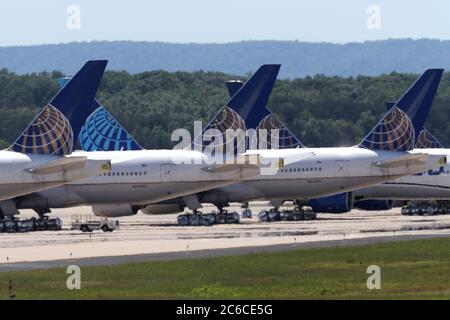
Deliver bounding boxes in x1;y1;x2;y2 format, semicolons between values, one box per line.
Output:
193;64;280;153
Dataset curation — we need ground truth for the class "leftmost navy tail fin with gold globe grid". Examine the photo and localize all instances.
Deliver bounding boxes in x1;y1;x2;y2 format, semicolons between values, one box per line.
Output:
9;60;107;155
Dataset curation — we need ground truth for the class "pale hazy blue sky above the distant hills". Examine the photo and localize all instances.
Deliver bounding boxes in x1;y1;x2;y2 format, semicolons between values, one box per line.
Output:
0;0;450;46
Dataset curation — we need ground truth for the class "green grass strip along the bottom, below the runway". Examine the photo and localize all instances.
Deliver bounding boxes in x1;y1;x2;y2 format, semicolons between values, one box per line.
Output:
0;238;450;299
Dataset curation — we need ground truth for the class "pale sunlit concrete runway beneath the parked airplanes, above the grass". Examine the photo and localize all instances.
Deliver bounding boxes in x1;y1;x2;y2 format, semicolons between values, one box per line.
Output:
0;203;450;272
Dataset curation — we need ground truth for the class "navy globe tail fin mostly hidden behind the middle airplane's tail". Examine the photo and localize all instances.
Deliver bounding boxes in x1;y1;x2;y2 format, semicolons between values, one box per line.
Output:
226;80;305;149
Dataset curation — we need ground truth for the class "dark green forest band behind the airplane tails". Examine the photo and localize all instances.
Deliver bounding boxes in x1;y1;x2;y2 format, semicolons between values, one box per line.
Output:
0;70;450;148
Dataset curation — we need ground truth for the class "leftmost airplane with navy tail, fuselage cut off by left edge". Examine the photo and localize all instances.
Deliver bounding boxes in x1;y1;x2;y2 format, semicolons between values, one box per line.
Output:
0;61;107;216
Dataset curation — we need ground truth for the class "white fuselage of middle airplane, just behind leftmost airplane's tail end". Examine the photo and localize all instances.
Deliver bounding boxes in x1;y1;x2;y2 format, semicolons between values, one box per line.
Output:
14;150;259;215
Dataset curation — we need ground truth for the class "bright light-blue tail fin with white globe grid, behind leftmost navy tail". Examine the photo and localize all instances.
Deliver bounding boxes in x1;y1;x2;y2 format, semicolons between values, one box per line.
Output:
58;77;143;151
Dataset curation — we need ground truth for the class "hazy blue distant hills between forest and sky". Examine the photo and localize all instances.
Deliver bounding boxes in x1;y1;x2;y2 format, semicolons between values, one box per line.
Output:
0;39;450;79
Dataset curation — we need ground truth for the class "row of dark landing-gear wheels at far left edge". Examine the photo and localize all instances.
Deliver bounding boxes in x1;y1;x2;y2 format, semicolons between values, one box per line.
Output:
0;216;63;233
